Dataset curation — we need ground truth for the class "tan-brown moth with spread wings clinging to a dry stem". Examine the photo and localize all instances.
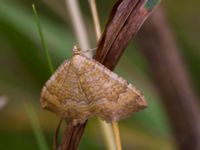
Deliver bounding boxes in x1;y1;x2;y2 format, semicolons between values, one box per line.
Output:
40;47;147;125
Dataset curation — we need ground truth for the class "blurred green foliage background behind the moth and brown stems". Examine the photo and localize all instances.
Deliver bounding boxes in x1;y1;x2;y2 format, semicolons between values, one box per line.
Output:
0;0;200;150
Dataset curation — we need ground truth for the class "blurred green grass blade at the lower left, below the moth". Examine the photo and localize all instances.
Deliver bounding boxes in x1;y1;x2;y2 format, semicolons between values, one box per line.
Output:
24;103;49;150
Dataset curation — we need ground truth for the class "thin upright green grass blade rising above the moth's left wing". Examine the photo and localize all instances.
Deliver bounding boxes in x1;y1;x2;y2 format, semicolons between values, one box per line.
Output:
32;4;54;74
